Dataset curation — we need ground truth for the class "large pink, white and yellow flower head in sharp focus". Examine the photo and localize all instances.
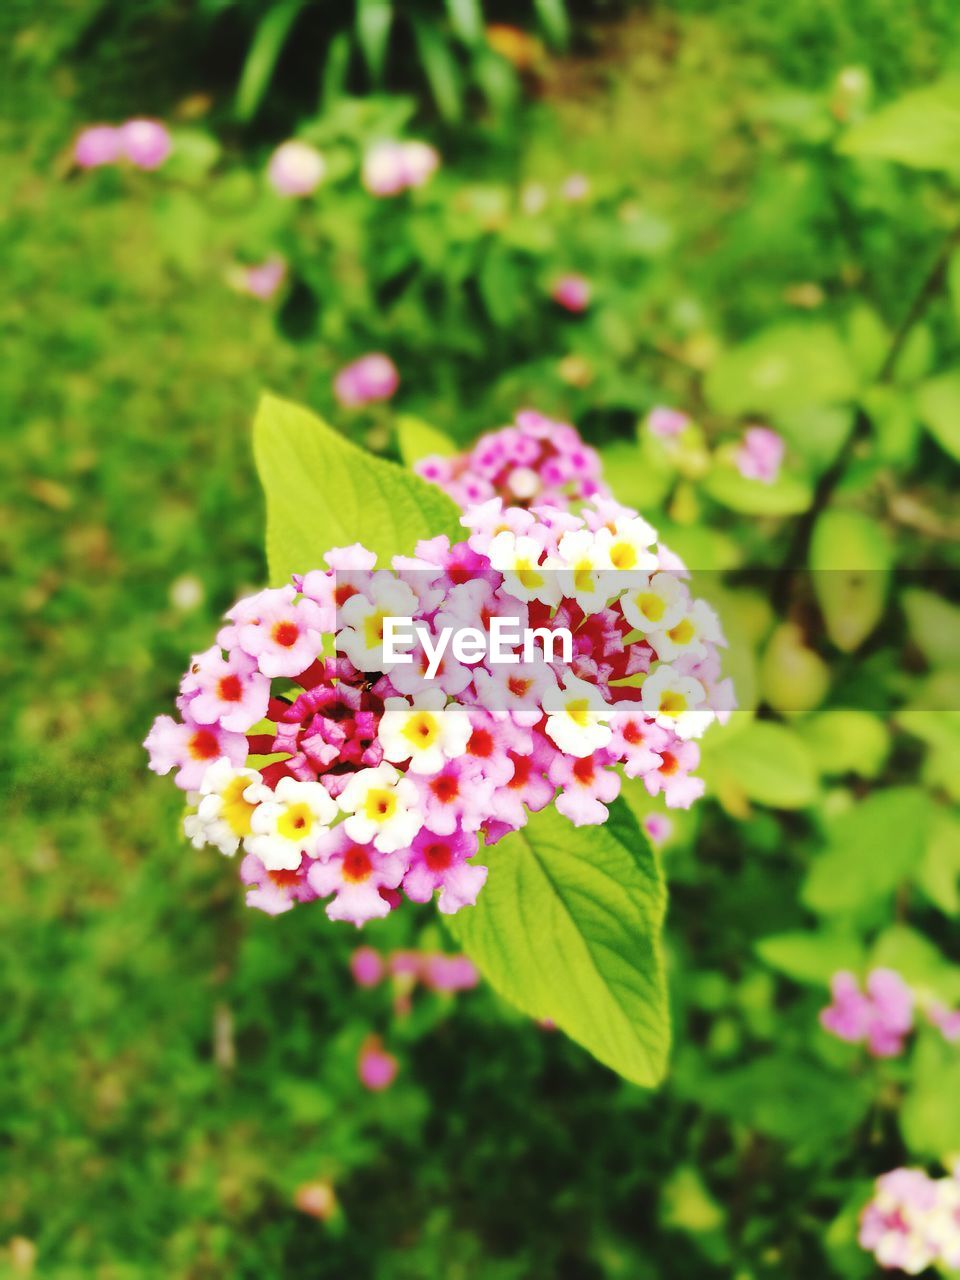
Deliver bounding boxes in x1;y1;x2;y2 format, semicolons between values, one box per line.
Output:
145;488;732;925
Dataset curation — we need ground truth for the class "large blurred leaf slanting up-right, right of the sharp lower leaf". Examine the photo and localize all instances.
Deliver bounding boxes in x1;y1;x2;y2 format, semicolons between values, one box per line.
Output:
801;787;933;915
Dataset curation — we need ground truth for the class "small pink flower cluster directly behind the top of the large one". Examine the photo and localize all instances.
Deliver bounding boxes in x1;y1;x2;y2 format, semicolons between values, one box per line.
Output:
413;410;608;509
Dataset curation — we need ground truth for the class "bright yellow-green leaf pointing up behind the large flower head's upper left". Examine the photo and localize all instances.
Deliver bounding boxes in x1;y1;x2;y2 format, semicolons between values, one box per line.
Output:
253;396;463;584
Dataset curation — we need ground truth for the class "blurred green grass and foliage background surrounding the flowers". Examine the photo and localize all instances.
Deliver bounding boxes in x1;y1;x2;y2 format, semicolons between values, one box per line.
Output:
0;0;960;1280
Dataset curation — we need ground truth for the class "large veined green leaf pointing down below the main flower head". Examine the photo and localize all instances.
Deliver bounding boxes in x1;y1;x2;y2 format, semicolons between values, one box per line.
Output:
448;800;669;1087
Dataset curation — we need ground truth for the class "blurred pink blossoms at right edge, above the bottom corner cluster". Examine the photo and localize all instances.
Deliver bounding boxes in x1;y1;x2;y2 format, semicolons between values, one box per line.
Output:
820;969;960;1057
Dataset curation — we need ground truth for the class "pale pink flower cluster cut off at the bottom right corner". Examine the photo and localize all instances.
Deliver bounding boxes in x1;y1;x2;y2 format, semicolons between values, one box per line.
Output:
859;1169;960;1276
